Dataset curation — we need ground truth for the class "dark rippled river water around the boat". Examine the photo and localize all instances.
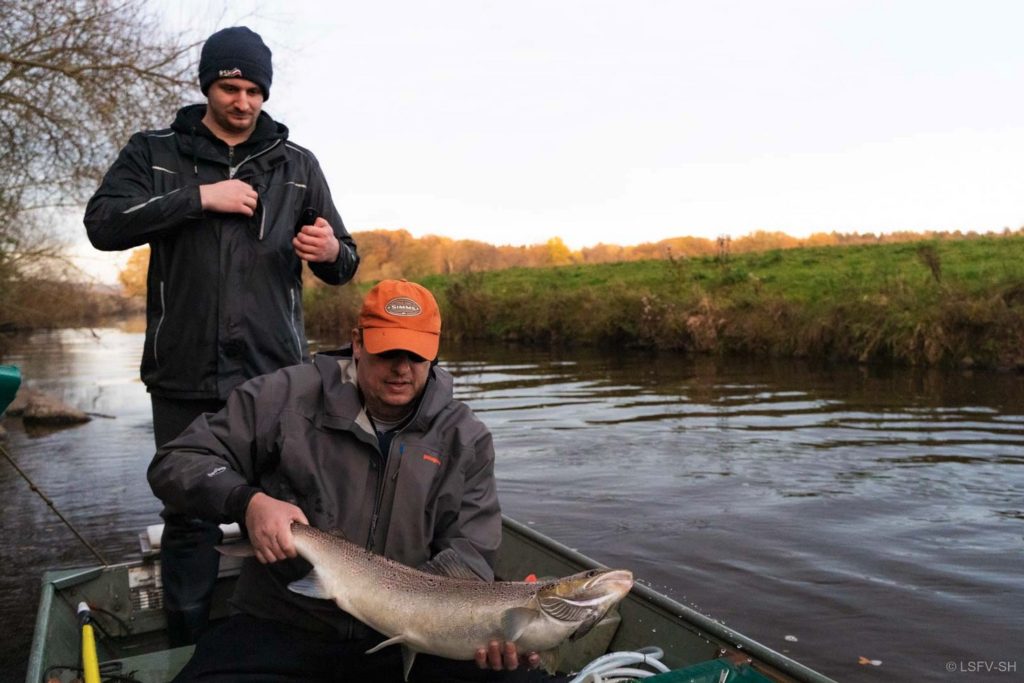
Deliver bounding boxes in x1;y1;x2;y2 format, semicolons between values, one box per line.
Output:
0;326;1024;681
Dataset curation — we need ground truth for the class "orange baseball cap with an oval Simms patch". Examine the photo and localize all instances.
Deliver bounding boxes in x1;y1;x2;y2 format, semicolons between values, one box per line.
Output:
358;280;441;360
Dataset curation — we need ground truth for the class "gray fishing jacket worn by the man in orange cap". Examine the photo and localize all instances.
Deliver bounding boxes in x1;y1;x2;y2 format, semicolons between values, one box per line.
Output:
148;348;501;637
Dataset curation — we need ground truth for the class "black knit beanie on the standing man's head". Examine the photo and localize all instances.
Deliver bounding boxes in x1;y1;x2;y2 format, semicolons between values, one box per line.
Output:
199;26;273;99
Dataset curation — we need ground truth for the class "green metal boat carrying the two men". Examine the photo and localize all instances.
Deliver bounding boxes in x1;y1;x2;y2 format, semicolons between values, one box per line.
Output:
26;517;831;683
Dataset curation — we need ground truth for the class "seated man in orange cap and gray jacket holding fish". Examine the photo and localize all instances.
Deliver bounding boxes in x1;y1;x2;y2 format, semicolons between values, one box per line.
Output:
148;281;544;681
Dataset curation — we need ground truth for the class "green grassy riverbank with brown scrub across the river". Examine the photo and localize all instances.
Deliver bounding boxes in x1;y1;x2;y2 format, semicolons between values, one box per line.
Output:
307;234;1024;370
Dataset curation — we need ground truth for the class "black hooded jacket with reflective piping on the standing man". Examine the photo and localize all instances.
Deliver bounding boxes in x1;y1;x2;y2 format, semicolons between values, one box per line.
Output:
85;104;358;400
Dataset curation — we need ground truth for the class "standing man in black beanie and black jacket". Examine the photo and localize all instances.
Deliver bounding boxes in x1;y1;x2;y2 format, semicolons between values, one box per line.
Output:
85;27;358;645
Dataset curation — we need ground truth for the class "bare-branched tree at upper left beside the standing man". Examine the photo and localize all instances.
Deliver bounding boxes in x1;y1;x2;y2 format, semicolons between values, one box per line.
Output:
0;0;198;305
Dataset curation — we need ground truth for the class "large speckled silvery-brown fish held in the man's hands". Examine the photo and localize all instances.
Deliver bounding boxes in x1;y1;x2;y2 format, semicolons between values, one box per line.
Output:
249;523;633;678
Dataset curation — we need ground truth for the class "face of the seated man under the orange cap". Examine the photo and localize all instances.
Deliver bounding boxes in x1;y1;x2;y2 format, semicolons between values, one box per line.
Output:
352;330;430;420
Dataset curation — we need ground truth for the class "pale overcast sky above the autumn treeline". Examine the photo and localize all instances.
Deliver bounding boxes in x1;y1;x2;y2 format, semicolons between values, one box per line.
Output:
74;0;1024;280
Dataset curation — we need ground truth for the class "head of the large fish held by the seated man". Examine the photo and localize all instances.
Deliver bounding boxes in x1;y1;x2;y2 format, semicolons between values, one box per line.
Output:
537;569;633;640
